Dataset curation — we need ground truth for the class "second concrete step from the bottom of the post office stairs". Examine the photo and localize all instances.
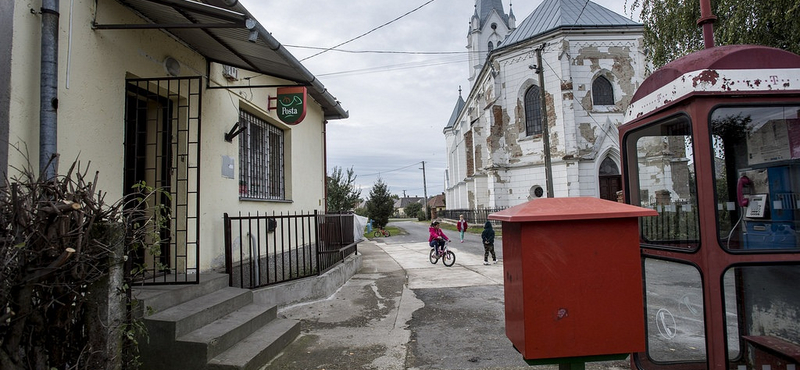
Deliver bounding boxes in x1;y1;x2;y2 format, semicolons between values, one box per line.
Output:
177;303;278;361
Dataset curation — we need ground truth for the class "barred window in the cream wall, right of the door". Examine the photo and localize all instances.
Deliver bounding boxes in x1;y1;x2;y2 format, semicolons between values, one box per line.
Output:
239;110;286;200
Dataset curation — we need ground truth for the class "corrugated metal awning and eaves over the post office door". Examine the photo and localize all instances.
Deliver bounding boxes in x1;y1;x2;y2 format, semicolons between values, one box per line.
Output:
93;0;348;120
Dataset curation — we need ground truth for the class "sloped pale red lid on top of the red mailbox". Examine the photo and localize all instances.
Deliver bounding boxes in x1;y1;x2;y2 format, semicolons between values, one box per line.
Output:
489;197;658;222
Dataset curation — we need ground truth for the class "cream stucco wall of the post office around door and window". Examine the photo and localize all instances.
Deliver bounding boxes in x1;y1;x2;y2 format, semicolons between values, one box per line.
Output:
8;0;325;271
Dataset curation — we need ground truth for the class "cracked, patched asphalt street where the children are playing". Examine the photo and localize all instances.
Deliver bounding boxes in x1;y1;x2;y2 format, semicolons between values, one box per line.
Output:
264;222;630;370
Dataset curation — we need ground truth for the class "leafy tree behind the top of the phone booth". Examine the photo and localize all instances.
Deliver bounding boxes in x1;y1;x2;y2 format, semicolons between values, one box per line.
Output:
626;0;800;68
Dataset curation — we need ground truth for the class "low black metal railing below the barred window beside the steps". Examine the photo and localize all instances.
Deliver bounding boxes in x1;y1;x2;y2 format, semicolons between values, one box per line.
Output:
224;211;358;289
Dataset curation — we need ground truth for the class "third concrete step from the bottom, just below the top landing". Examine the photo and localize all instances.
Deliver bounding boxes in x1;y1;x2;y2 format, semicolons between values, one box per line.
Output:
145;288;253;337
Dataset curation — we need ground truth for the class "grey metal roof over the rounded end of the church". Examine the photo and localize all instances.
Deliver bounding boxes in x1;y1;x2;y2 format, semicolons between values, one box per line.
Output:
503;0;641;47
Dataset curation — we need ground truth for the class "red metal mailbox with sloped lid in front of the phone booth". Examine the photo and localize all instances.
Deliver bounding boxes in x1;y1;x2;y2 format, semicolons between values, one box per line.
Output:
489;197;656;364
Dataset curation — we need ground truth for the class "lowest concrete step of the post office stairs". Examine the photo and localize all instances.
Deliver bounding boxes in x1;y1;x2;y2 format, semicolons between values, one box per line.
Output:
206;319;300;370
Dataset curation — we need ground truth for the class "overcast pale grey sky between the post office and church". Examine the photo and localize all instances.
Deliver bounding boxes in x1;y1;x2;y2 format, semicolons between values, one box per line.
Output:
239;0;630;198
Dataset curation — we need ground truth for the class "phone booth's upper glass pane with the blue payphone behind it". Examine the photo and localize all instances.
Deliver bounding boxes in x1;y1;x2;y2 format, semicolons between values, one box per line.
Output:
711;105;800;252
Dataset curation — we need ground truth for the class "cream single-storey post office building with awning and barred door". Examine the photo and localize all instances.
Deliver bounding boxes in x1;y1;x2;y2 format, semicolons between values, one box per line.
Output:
0;0;348;274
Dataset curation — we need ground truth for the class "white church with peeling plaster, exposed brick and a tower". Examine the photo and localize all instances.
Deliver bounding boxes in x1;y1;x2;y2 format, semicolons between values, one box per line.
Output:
443;0;647;209
